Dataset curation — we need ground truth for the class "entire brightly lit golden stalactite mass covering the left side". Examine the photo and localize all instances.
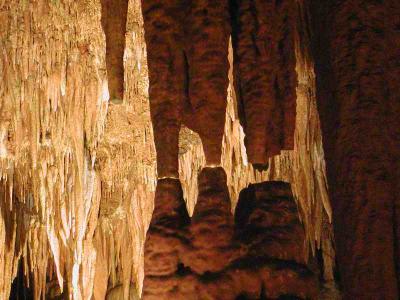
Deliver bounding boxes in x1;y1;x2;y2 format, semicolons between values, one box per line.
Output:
0;0;156;299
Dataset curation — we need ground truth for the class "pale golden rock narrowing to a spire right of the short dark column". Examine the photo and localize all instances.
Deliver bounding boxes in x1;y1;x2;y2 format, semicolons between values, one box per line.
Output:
95;0;157;300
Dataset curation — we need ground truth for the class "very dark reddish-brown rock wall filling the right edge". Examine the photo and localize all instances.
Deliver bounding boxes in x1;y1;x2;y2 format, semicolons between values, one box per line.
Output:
309;0;400;299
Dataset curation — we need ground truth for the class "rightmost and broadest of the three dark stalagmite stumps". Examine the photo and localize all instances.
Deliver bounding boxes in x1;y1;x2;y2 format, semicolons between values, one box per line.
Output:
235;182;318;299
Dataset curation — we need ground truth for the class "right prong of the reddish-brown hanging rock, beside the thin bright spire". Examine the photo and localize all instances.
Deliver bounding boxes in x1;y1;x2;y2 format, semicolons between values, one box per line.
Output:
182;0;231;165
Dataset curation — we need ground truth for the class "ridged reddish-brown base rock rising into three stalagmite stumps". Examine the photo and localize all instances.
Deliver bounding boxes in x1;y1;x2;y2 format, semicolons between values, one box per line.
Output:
143;168;318;300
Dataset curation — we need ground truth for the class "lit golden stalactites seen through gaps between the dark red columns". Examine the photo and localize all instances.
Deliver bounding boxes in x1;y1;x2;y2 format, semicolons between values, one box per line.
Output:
179;35;335;281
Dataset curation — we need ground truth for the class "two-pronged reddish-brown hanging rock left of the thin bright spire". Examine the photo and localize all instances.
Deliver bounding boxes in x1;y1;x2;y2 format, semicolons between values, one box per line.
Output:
142;0;230;177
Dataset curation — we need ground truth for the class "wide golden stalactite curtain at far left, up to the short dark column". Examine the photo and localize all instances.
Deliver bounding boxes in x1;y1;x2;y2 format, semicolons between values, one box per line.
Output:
0;1;107;299
